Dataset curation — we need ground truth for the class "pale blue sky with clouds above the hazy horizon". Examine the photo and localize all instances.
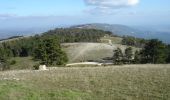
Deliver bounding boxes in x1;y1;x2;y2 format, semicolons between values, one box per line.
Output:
0;0;170;29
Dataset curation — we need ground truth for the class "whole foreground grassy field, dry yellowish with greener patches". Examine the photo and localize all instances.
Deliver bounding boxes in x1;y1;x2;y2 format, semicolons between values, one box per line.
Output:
0;65;170;100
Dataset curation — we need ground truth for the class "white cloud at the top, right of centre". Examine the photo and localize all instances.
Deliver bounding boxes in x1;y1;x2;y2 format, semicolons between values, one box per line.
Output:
84;0;139;14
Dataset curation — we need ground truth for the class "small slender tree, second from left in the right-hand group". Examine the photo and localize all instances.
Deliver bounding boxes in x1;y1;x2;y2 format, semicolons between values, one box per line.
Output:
124;47;133;63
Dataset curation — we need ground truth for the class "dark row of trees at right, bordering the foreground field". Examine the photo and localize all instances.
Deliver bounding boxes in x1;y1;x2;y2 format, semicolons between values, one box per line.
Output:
113;39;170;64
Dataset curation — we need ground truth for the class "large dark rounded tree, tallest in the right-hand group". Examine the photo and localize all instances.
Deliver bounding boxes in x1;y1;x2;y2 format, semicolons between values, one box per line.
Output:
142;39;166;64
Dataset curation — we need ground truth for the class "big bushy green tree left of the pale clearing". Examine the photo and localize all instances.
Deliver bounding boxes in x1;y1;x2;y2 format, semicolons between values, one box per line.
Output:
34;38;68;65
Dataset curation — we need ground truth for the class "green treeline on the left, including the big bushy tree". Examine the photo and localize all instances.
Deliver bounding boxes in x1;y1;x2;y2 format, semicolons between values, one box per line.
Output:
0;36;68;70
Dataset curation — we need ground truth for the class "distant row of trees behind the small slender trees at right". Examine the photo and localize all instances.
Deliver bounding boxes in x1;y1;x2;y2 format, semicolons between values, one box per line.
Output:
122;36;148;48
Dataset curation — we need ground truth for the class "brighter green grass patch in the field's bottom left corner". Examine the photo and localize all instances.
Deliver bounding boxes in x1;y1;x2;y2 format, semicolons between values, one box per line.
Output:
0;81;89;100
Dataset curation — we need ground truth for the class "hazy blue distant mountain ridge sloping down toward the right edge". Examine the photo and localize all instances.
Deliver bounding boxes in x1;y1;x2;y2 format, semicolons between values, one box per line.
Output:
71;23;170;43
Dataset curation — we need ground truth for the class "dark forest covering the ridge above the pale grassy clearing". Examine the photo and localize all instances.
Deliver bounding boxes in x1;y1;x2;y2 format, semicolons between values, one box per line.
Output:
43;28;112;43
